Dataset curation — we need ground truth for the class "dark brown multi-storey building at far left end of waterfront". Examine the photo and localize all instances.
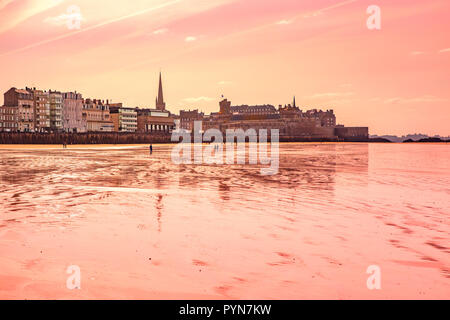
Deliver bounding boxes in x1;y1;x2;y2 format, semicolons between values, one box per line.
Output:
2;88;34;132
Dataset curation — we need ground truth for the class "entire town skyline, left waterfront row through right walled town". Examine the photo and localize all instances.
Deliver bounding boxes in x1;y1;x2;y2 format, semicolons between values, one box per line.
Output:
0;73;369;140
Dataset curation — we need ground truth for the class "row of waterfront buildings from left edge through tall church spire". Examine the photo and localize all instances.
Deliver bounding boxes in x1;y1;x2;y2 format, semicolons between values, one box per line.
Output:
0;74;175;133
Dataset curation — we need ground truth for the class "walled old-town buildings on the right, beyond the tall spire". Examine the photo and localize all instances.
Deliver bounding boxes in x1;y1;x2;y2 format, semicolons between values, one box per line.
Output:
179;98;369;141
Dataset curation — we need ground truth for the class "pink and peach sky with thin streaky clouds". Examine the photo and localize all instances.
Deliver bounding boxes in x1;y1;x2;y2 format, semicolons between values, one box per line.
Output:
0;0;450;135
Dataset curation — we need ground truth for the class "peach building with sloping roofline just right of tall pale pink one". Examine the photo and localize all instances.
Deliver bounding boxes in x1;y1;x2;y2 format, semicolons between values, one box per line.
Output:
82;99;114;132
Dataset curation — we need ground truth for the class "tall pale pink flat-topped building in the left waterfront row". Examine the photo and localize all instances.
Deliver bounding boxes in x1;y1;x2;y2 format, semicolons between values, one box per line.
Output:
62;91;87;133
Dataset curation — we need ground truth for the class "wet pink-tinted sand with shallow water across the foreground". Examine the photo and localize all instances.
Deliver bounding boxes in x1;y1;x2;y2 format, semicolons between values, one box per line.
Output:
0;143;450;299
